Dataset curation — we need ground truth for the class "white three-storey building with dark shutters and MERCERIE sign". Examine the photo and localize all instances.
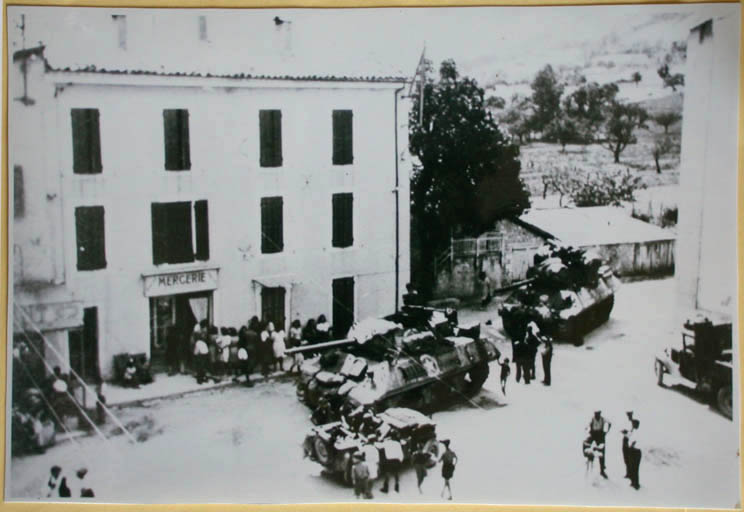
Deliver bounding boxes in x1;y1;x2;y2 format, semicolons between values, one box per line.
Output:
8;7;416;378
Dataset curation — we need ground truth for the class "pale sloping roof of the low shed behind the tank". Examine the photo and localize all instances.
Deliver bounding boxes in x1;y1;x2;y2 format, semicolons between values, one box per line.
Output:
519;206;676;247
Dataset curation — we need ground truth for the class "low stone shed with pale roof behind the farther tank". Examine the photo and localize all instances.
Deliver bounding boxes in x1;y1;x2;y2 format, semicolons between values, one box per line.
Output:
436;206;675;297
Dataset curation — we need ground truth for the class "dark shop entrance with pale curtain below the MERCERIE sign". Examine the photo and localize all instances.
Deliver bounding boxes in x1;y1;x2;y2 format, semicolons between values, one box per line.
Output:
150;291;212;371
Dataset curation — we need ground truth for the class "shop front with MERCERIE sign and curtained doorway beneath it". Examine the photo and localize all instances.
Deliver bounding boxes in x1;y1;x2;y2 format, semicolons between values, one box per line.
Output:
142;267;219;371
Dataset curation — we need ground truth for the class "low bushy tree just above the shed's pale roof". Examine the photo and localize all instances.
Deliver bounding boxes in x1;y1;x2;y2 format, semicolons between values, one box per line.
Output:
571;169;646;207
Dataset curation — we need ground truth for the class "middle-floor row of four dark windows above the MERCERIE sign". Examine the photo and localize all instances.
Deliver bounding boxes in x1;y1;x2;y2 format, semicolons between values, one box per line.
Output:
75;193;354;271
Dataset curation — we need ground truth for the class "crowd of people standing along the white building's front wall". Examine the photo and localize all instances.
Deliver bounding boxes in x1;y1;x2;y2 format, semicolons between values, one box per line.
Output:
166;315;332;386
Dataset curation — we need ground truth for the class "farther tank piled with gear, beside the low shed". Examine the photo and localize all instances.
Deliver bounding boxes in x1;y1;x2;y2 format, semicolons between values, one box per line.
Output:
499;244;620;345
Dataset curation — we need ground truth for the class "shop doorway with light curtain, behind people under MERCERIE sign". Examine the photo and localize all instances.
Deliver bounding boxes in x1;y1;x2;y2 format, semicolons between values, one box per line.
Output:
150;291;212;372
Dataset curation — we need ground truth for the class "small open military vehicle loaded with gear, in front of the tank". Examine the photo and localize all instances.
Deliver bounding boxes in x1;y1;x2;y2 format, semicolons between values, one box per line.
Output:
302;407;439;484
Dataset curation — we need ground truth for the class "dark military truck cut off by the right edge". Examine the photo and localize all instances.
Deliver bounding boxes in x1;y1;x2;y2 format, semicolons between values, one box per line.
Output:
654;313;733;419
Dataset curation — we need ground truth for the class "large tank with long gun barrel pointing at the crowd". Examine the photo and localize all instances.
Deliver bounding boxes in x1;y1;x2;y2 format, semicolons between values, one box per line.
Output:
297;306;500;424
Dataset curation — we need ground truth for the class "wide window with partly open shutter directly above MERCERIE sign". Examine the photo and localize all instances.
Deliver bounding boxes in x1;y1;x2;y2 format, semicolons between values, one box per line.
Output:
151;200;209;265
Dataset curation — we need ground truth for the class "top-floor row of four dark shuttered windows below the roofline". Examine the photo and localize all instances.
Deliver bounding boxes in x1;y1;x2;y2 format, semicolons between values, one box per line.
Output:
71;108;354;174
